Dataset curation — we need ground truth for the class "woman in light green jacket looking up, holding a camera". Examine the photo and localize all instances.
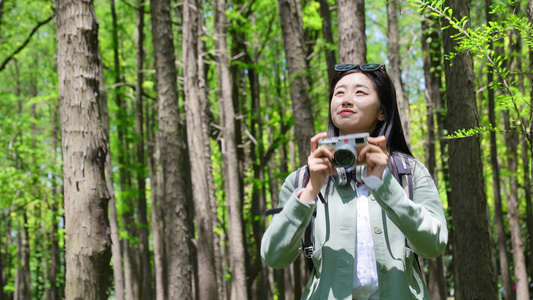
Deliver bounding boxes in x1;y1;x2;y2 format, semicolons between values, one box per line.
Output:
261;64;448;299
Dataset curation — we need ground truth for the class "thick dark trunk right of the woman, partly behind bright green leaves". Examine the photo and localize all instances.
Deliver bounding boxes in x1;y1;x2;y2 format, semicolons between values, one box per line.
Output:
443;0;498;299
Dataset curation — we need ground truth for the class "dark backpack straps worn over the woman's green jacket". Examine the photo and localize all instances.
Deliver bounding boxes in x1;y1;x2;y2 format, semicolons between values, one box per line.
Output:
266;153;412;273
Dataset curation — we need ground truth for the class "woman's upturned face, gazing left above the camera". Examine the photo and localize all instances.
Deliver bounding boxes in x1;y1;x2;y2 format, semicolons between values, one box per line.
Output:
331;72;385;135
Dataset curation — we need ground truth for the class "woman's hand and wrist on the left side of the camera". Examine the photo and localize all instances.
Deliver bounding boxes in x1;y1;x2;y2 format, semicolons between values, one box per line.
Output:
300;132;336;203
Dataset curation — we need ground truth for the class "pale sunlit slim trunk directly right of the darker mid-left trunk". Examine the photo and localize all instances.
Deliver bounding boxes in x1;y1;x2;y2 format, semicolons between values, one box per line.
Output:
182;0;218;299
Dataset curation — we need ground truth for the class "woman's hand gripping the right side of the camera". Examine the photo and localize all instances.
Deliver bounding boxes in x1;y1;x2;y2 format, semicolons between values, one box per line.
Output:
357;135;389;179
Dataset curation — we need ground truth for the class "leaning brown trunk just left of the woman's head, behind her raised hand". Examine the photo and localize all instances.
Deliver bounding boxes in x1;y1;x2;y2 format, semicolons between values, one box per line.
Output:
278;0;315;164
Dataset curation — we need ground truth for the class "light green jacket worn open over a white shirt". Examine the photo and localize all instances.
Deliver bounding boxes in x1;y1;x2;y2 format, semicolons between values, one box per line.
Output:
261;158;448;300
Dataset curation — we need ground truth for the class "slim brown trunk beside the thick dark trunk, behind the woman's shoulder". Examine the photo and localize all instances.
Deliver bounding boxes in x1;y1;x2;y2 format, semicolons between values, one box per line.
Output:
422;15;446;300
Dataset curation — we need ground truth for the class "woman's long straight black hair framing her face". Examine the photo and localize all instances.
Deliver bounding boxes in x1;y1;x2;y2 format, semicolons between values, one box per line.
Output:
328;68;413;156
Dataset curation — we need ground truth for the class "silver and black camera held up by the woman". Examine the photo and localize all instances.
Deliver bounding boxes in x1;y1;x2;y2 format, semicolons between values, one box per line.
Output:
318;133;369;185
